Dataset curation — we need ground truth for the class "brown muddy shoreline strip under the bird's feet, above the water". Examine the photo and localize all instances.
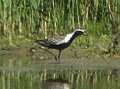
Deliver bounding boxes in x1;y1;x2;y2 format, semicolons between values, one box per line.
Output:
0;44;120;71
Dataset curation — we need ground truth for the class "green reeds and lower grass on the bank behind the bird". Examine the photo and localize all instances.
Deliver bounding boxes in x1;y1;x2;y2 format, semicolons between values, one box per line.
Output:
0;0;120;54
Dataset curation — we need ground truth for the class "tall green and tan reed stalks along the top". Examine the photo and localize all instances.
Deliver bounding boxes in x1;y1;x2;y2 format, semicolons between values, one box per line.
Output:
0;0;120;36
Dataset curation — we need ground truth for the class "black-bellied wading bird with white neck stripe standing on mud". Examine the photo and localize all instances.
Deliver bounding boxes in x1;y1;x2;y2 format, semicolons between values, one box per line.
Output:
36;29;85;62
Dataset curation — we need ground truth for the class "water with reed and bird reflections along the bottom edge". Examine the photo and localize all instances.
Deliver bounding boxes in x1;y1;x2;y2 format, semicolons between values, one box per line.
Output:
0;69;120;89
